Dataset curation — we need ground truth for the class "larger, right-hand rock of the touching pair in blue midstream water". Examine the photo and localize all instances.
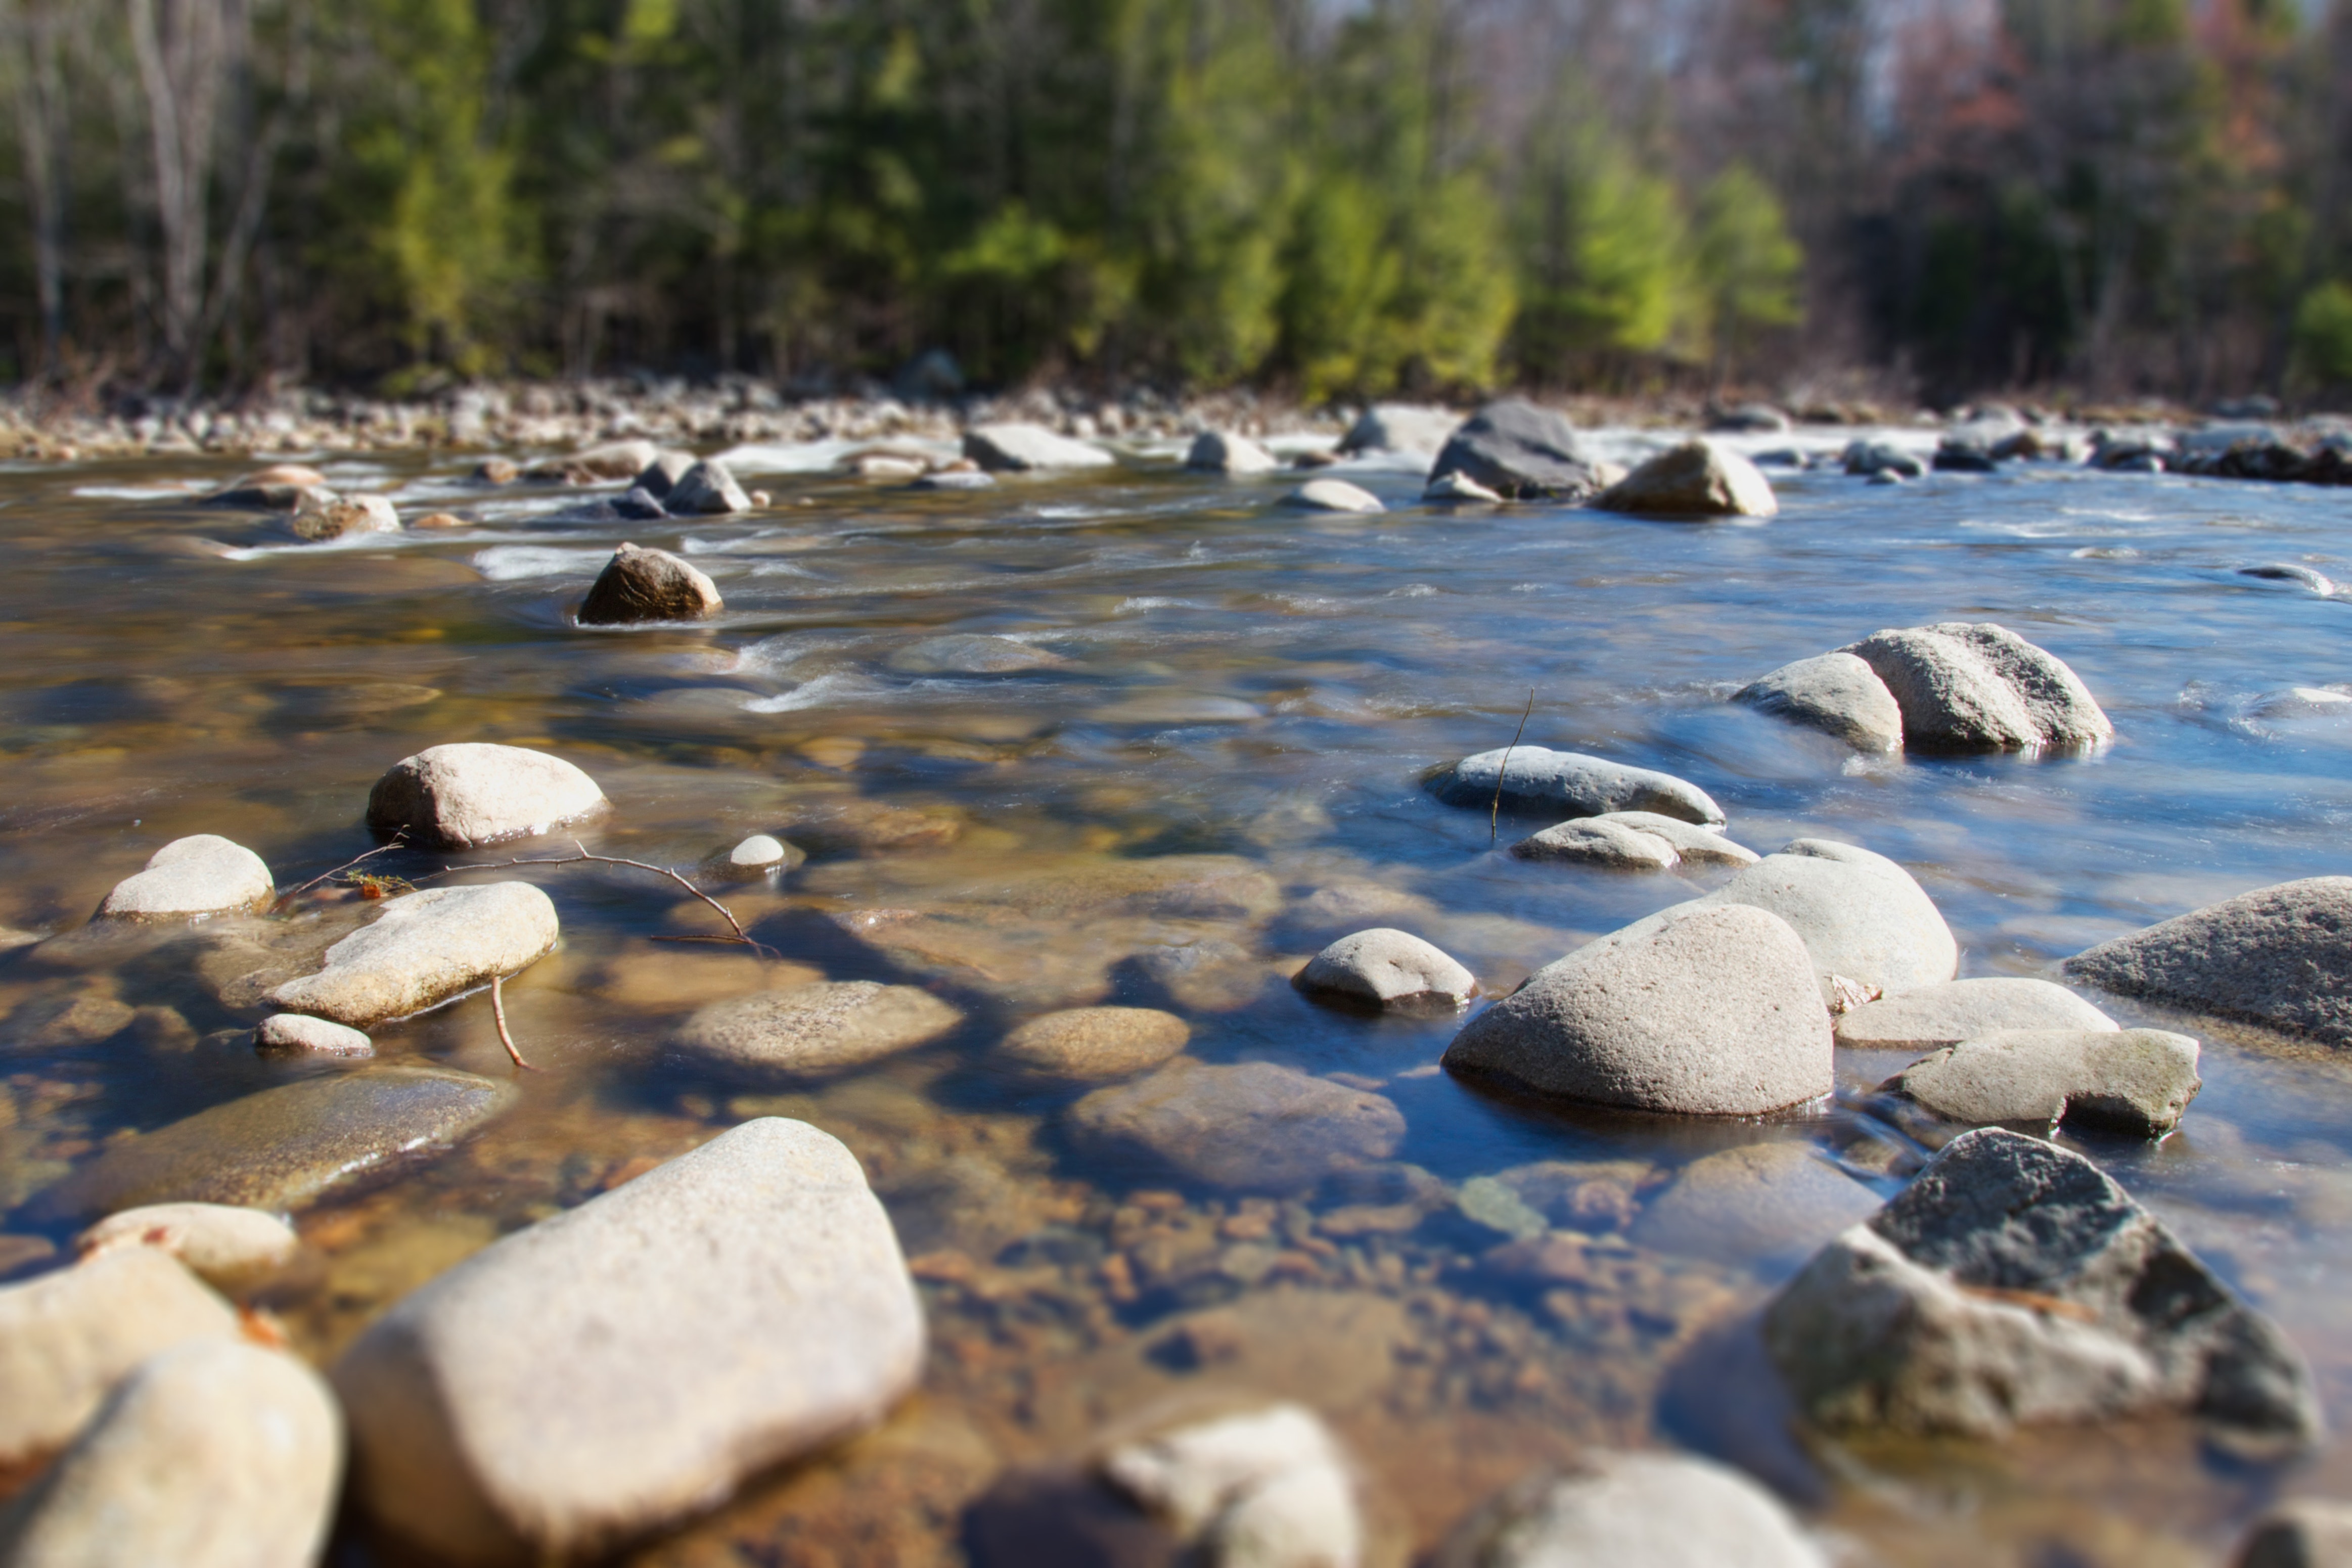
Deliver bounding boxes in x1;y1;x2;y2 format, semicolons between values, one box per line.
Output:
1842;621;2114;752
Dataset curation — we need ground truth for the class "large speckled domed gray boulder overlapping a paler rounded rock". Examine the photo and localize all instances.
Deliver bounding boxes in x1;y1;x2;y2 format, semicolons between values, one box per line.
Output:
1444;905;1835;1117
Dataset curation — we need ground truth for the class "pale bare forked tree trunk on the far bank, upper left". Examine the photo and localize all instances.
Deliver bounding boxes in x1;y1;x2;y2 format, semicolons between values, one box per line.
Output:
127;0;249;386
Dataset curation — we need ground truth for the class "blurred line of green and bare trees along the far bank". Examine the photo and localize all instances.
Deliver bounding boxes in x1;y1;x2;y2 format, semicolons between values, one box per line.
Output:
0;0;2352;400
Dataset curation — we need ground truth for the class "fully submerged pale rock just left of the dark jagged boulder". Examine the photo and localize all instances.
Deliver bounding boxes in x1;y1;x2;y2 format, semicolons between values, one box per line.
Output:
1627;1142;1879;1267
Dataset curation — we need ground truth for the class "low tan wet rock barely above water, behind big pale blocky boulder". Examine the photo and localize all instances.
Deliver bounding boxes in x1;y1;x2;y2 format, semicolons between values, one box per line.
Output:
677;980;964;1077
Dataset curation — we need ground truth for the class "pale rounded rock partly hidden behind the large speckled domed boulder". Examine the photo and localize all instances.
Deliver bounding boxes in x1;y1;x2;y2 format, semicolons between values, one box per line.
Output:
1700;839;1959;1001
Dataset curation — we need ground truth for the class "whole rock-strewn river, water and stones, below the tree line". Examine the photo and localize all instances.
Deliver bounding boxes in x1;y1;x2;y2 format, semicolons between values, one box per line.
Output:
0;399;2352;1568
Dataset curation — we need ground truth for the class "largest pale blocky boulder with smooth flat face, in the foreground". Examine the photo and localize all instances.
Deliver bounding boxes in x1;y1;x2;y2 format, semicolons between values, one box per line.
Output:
334;1117;924;1563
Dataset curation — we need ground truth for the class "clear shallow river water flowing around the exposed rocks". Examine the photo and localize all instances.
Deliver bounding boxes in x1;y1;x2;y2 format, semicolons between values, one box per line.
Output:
0;437;2352;1563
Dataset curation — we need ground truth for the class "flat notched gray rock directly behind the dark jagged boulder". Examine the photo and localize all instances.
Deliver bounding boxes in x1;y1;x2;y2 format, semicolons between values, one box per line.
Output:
1886;1027;2204;1138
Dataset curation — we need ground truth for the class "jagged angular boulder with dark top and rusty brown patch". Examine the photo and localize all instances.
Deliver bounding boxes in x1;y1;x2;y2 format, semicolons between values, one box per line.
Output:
1764;1128;2322;1450
